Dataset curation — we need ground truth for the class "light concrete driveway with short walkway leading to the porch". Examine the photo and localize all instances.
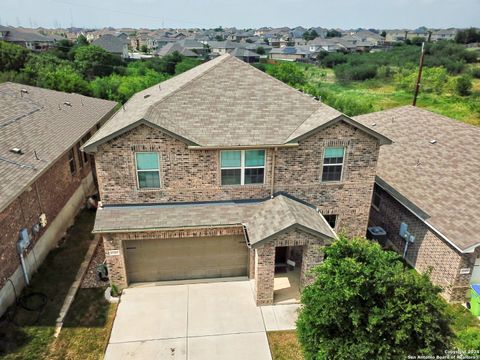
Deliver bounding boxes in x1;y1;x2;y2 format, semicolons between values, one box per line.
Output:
105;280;298;360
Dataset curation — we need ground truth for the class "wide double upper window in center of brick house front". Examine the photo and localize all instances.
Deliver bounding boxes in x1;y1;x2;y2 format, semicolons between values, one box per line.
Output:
220;150;265;185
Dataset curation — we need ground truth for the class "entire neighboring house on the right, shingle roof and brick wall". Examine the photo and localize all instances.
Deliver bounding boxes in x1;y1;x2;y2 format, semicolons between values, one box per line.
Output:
355;106;480;301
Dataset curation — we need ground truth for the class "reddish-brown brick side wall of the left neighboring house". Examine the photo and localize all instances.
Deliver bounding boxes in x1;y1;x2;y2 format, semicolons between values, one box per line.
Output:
0;145;91;288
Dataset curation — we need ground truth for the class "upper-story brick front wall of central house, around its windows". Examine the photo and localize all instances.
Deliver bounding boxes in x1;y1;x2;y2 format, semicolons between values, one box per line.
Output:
96;122;379;239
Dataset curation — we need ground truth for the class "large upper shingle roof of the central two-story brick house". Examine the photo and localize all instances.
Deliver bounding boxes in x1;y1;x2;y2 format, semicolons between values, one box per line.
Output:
85;54;390;152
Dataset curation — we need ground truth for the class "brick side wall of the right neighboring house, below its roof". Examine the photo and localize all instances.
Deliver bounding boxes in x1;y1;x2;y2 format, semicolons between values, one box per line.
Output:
370;186;477;302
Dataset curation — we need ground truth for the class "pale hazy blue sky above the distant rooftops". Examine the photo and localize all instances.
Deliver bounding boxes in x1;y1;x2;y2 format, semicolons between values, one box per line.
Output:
0;0;480;29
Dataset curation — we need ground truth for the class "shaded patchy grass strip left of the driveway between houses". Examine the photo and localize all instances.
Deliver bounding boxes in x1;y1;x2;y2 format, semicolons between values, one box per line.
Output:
0;211;112;360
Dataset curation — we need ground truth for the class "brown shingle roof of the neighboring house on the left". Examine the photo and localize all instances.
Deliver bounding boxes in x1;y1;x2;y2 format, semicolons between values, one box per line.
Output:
0;83;116;211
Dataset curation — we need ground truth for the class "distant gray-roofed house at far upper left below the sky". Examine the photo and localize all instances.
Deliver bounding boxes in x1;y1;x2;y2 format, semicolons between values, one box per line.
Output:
0;25;56;51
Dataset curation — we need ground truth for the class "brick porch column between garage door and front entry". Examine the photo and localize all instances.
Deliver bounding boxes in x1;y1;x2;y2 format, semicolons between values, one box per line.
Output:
255;244;275;306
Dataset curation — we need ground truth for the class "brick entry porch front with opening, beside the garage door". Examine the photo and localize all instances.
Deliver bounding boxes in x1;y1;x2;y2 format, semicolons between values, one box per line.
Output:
251;228;325;305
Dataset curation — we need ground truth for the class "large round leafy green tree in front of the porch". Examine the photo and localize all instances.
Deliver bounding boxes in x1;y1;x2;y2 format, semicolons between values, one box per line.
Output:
297;236;453;360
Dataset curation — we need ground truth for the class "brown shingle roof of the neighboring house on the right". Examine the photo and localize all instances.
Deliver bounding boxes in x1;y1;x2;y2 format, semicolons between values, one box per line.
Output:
355;106;480;252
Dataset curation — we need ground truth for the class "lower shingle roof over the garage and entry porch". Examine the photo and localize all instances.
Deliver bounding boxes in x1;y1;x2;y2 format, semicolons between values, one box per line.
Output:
93;195;336;247
